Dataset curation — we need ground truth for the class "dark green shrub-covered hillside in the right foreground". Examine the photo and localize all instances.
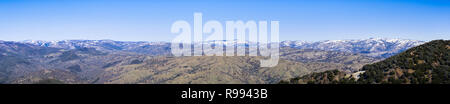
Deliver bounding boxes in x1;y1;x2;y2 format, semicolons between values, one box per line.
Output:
280;40;450;84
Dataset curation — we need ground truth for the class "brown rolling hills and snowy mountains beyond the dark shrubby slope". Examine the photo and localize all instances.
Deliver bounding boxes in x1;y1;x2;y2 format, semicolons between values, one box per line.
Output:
0;38;424;84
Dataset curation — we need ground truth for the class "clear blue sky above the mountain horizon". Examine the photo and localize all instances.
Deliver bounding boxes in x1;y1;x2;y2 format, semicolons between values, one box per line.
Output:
0;0;450;41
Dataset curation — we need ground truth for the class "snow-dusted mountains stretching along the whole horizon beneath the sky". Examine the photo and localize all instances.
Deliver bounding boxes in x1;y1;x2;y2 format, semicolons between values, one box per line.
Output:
22;38;425;58
